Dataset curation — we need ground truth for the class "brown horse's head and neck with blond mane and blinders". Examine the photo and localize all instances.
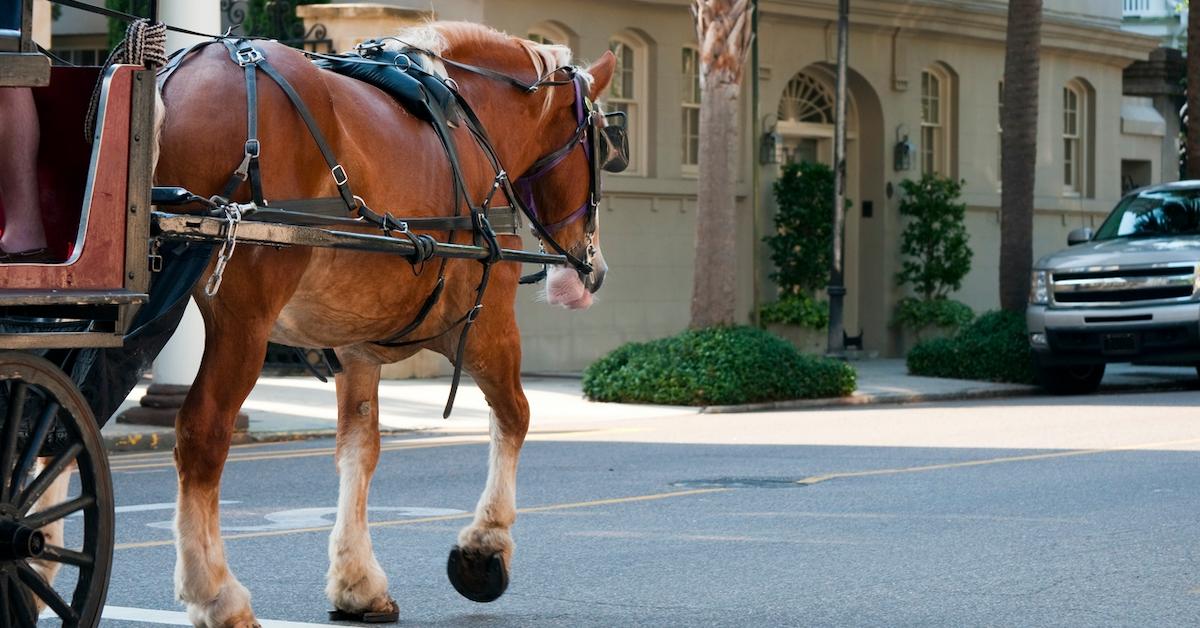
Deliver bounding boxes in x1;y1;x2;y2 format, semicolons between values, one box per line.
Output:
401;23;628;310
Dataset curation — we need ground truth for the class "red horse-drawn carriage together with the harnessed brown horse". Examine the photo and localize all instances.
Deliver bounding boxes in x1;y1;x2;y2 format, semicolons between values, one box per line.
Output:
0;0;628;627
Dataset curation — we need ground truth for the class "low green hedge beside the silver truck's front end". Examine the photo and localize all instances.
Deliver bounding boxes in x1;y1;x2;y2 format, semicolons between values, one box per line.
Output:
907;311;1033;384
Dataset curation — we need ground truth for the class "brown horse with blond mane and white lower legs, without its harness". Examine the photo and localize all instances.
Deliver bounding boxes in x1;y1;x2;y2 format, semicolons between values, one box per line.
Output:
156;23;614;627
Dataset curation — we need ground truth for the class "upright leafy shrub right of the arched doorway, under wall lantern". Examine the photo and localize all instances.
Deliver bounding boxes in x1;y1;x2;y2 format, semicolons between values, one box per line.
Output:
896;174;972;301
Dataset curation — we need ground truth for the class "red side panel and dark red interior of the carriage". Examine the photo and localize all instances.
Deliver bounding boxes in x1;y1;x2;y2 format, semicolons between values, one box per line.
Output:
0;66;137;289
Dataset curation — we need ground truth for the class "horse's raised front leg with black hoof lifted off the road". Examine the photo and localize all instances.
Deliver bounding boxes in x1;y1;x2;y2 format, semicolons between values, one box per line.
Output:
446;331;529;602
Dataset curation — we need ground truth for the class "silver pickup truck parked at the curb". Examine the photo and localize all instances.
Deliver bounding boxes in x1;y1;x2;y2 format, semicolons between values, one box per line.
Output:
1026;181;1200;394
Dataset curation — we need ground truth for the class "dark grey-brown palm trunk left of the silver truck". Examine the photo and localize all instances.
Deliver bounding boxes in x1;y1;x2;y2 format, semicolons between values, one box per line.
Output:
1000;0;1042;312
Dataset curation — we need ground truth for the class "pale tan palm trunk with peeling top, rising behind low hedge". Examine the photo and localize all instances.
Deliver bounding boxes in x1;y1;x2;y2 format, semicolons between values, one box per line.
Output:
691;0;750;328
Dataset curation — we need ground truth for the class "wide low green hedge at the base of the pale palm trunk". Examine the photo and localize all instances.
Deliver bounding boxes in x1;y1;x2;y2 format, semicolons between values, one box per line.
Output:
583;327;857;406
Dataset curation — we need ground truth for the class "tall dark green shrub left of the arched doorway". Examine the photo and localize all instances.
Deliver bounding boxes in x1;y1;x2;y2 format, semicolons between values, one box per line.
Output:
763;162;833;295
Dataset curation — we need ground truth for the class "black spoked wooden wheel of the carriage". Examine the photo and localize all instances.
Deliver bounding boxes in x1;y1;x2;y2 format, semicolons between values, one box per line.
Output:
0;353;114;628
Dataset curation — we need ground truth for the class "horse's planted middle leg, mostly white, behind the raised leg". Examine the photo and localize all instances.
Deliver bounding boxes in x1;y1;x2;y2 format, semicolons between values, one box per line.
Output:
325;357;398;621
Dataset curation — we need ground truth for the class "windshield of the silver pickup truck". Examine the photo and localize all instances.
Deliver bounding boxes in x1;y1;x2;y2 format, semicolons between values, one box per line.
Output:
1094;190;1200;240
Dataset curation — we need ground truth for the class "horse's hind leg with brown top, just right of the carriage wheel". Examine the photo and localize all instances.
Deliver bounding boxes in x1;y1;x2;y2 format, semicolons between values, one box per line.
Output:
175;307;270;628
